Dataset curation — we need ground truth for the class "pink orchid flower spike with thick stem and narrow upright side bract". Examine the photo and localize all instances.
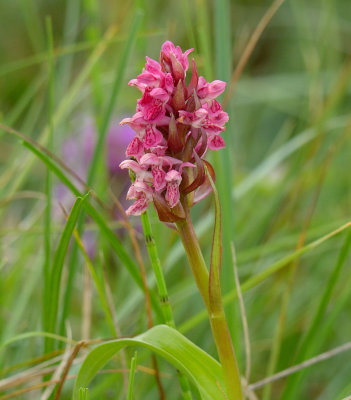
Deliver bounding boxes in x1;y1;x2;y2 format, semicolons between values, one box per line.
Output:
120;41;242;400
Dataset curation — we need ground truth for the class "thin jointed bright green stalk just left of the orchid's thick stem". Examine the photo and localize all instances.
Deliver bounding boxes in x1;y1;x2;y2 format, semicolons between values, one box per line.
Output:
140;211;193;400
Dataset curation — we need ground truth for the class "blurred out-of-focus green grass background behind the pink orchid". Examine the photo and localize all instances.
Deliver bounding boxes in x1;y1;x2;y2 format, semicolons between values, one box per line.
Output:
0;0;351;400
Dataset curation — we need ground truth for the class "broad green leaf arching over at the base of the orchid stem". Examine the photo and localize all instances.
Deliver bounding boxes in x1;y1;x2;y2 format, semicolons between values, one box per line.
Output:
73;325;225;400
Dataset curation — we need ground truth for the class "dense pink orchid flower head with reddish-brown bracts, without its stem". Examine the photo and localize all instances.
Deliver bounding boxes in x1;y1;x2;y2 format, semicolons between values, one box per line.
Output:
120;41;228;222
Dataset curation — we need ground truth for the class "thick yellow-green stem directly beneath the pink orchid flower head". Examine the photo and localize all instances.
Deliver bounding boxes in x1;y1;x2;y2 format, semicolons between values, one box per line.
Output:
176;207;243;400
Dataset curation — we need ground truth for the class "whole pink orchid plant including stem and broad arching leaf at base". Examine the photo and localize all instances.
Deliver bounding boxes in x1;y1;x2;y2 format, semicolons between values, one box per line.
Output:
74;41;244;400
